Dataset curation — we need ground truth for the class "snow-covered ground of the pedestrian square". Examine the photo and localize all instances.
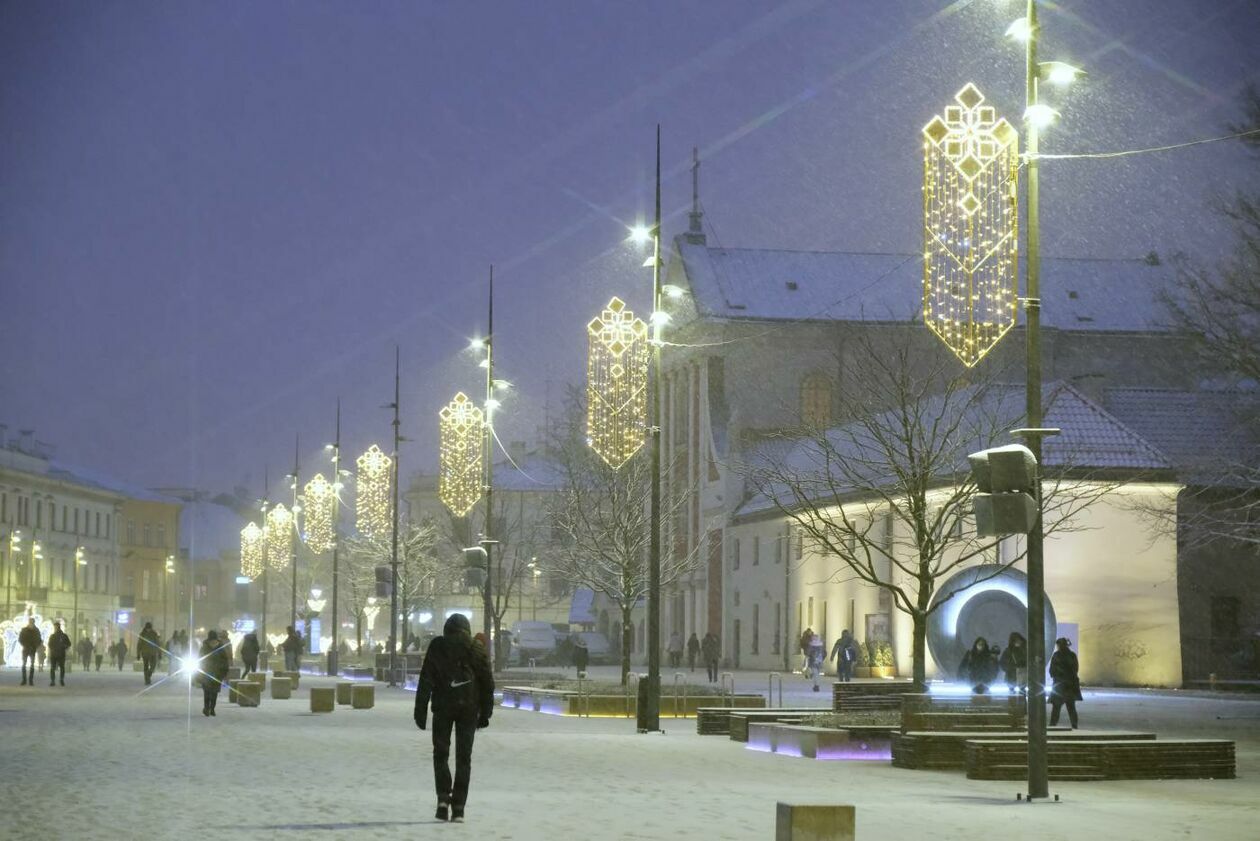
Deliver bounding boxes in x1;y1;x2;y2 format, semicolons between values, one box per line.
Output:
0;670;1260;841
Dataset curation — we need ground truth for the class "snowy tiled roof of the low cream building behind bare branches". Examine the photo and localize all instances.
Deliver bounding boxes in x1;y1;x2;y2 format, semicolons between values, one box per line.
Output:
736;382;1172;517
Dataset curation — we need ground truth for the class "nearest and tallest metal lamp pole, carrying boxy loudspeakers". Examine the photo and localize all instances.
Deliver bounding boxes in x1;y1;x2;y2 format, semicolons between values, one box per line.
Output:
1024;0;1050;798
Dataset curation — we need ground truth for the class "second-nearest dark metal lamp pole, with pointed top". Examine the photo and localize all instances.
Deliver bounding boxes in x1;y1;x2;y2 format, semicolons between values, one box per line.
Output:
641;122;662;731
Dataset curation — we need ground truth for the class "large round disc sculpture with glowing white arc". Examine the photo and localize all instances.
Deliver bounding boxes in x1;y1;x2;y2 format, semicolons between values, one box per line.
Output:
927;564;1058;677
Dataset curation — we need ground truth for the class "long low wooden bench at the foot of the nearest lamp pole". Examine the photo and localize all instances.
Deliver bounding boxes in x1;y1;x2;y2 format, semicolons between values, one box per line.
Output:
965;739;1236;780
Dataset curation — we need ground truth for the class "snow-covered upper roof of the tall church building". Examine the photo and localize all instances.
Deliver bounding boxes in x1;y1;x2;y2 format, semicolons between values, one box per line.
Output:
675;238;1171;332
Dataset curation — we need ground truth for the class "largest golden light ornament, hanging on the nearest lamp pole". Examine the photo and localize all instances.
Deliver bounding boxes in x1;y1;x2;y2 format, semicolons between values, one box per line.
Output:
924;84;1019;367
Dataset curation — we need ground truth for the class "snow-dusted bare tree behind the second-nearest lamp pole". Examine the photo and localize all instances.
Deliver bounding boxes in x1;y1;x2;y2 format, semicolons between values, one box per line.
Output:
551;390;699;685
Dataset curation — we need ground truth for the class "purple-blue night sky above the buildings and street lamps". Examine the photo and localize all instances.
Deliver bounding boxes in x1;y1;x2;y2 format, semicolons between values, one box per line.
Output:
0;0;1260;493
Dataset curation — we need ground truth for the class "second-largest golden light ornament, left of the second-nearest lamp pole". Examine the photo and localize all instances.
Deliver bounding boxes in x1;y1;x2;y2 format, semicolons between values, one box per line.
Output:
586;298;649;469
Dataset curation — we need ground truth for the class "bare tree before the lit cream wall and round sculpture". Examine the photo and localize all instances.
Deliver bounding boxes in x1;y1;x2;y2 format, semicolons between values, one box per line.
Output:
743;334;1106;687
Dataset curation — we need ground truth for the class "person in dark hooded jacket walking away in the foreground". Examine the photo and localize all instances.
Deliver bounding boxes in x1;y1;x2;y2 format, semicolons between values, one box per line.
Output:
415;613;494;821
